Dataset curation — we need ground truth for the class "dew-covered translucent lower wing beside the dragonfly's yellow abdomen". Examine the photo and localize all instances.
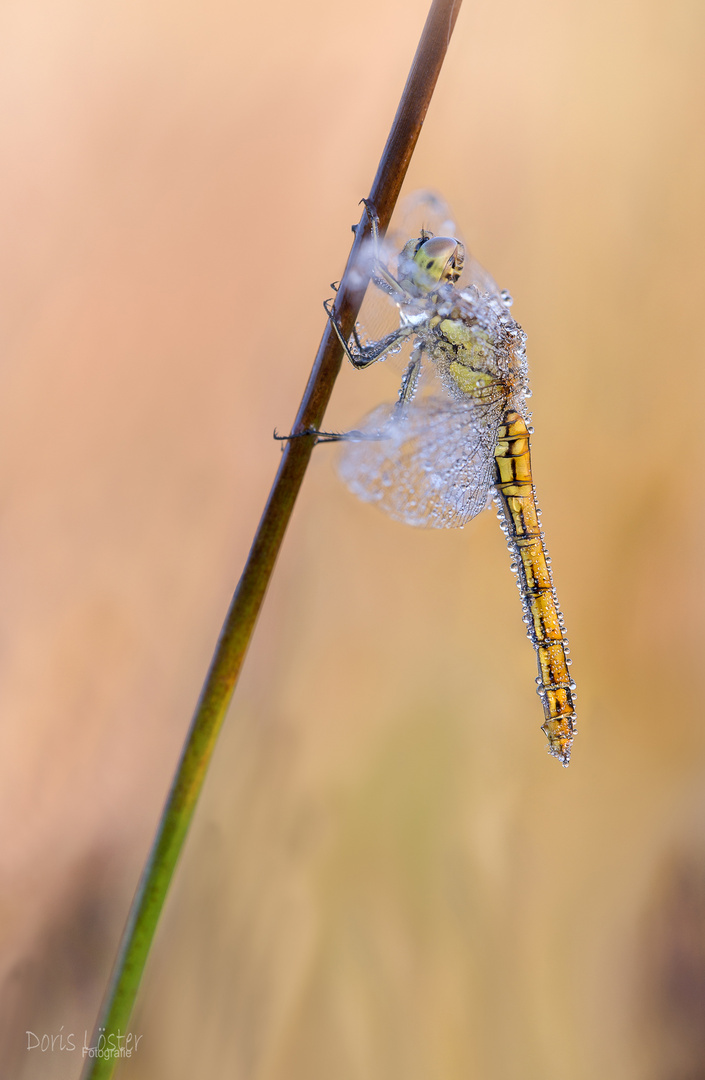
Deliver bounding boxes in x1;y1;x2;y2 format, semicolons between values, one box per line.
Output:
338;395;505;528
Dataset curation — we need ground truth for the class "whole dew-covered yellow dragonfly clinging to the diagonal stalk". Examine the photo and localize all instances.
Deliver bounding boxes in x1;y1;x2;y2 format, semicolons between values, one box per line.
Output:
315;192;575;766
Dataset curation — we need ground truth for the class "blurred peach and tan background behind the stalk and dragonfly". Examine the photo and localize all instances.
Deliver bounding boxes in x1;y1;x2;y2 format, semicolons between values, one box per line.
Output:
0;0;705;1080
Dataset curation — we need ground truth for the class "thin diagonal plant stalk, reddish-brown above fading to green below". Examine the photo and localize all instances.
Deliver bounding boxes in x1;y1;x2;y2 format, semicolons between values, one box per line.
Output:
83;0;461;1080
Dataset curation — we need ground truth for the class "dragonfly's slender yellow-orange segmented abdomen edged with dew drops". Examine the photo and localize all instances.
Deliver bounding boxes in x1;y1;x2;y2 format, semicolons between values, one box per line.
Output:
494;409;575;766
